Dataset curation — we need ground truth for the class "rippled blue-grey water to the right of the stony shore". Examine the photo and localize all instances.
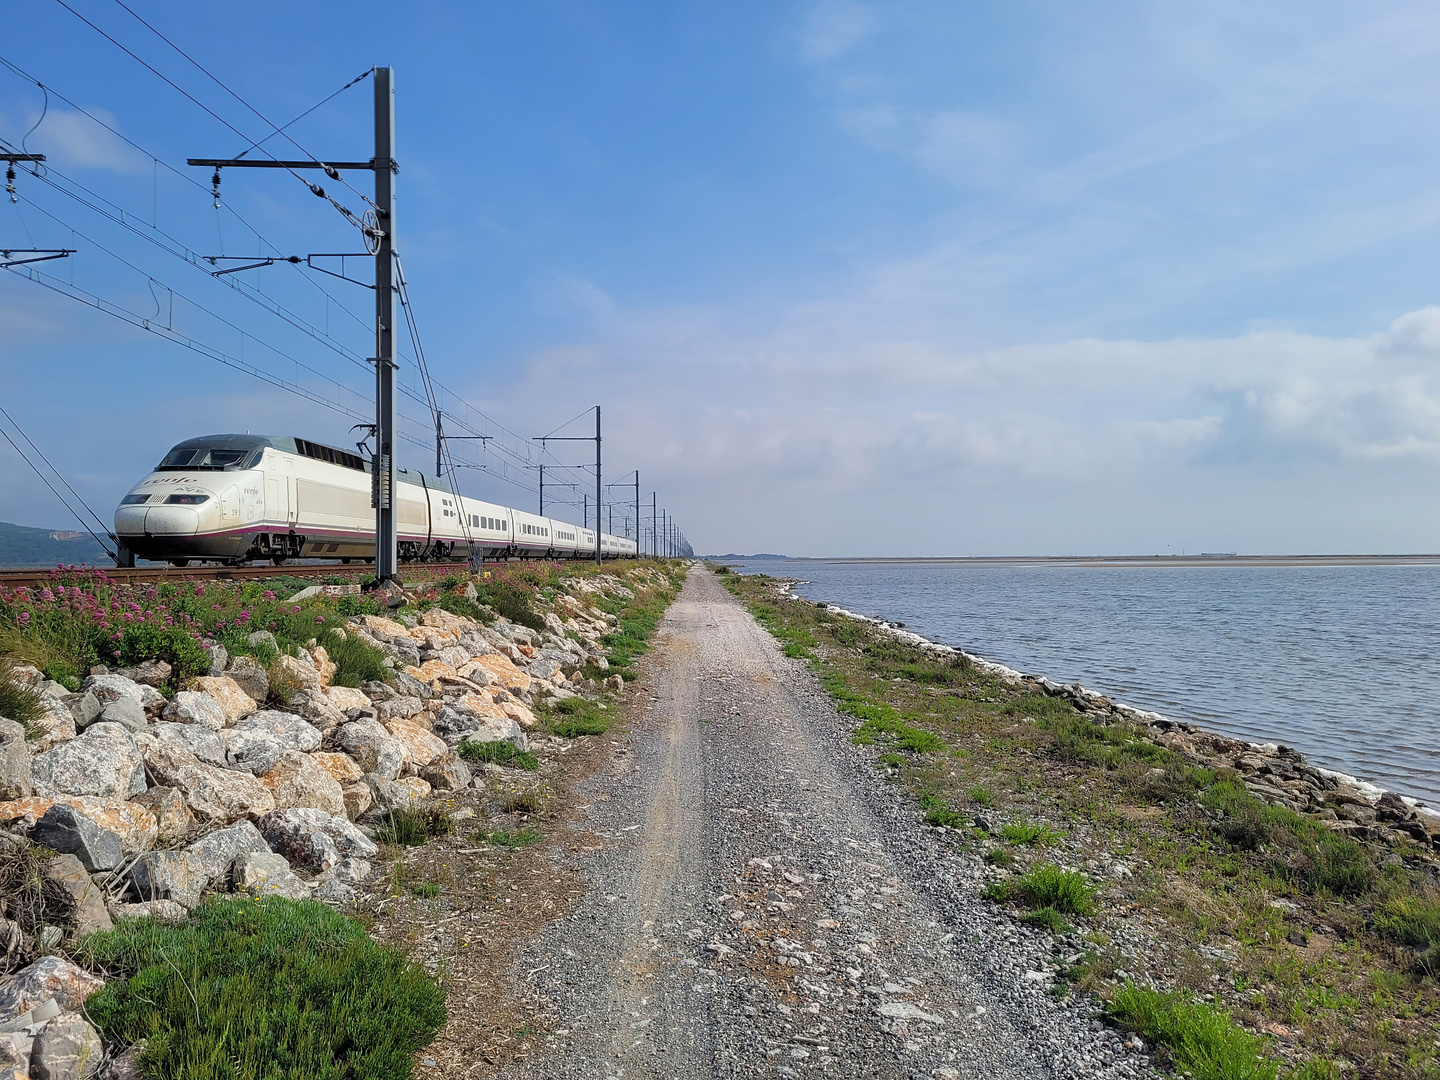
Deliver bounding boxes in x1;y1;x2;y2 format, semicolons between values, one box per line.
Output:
725;560;1440;805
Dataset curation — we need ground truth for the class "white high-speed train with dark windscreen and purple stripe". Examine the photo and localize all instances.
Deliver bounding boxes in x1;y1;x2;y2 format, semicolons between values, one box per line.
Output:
115;435;636;566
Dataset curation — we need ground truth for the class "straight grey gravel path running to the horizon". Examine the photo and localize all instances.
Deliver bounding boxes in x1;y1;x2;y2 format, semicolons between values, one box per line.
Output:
495;569;1155;1080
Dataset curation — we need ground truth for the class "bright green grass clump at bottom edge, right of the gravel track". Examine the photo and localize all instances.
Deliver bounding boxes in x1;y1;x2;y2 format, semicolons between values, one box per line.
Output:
1110;982;1279;1080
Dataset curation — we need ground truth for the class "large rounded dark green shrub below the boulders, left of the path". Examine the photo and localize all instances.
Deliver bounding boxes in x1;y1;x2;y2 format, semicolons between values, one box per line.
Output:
85;897;445;1080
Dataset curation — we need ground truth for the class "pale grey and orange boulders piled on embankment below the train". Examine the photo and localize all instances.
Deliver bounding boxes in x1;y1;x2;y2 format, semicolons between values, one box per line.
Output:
0;569;660;1077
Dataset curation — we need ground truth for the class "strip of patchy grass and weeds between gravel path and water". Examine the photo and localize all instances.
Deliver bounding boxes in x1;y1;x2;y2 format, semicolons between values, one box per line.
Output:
721;575;1440;1080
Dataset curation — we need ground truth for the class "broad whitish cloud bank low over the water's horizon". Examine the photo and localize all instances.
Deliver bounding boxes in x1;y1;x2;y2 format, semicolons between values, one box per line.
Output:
455;289;1440;554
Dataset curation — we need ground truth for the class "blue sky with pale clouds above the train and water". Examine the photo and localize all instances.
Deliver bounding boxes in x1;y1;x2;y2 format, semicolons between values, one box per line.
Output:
0;0;1440;554
